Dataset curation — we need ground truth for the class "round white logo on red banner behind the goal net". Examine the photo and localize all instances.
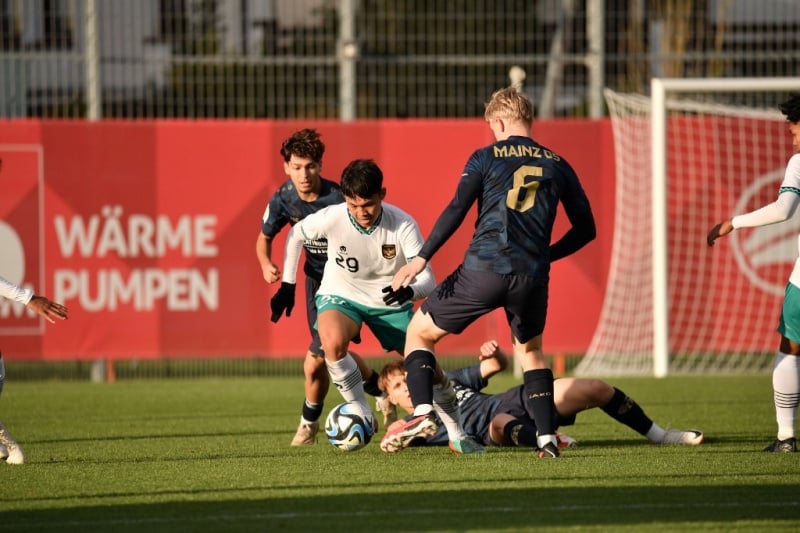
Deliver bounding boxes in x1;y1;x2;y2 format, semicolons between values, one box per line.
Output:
731;170;800;296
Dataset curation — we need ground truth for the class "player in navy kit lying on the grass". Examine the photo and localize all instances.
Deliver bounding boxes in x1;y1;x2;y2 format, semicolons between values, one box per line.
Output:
378;340;704;451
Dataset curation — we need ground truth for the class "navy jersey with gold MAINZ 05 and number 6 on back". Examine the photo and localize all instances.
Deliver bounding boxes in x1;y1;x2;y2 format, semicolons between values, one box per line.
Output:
419;136;591;279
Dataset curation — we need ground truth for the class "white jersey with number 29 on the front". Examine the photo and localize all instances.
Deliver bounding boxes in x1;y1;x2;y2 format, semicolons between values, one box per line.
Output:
283;202;435;308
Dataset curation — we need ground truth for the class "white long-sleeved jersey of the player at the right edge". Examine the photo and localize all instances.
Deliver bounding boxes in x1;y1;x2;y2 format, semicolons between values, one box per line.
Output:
731;154;800;287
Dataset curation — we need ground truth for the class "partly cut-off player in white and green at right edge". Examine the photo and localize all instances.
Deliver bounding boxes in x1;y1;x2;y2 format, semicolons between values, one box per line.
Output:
706;93;800;452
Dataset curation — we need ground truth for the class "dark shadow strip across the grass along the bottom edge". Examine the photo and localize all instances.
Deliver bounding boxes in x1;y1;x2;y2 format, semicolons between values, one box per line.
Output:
0;481;800;533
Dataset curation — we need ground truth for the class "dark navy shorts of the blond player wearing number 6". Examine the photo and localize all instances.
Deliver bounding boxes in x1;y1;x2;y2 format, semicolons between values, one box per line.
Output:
420;265;548;342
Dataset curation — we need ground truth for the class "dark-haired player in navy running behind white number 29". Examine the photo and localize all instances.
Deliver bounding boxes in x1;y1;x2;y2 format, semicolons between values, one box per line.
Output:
256;128;390;446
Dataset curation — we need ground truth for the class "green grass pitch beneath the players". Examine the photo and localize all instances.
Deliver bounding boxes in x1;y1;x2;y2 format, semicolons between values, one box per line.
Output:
0;368;800;533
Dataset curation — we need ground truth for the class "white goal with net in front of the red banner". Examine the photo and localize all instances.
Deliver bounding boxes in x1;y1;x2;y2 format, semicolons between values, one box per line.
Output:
575;78;800;376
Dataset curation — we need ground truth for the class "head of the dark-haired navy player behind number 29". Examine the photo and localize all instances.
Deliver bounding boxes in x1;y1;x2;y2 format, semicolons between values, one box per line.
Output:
281;128;325;194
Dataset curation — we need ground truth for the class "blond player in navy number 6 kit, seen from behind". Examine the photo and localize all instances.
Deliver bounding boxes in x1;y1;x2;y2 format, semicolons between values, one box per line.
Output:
382;88;596;457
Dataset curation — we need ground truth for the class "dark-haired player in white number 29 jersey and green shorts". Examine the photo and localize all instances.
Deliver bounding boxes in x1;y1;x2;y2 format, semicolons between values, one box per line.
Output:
283;159;435;440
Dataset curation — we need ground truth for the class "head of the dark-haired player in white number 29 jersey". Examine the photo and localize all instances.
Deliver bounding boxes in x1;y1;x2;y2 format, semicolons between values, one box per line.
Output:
341;159;386;228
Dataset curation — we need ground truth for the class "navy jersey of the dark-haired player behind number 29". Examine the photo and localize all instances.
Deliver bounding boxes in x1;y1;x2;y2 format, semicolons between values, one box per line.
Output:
261;178;344;281
